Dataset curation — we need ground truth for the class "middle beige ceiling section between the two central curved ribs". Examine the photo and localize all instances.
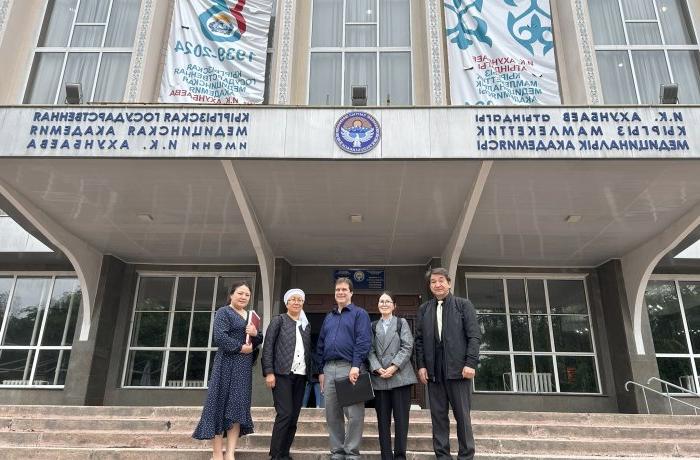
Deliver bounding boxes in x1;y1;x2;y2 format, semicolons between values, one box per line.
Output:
235;160;480;265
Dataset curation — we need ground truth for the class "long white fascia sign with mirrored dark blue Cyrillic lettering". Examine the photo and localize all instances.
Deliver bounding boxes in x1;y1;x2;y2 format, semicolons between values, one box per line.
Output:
0;105;700;159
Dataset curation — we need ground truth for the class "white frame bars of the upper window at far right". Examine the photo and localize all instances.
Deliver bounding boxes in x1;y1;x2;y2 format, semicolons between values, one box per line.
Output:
589;0;700;105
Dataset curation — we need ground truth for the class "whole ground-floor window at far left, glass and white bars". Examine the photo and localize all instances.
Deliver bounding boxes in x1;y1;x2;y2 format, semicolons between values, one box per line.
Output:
0;274;81;388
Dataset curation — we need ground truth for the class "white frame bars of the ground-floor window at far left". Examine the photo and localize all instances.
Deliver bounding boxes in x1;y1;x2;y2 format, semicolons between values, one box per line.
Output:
0;271;83;390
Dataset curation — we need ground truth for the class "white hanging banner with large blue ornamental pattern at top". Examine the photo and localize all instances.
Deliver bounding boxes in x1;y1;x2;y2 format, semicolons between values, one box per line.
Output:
445;0;561;105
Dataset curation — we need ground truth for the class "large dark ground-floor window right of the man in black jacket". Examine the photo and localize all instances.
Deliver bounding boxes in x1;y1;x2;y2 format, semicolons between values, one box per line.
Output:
467;275;600;393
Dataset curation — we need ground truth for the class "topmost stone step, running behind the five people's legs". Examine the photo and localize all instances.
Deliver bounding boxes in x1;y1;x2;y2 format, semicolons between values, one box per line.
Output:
0;406;700;427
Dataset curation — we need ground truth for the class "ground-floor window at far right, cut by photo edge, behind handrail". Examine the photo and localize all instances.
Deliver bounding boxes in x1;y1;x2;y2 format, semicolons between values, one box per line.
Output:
644;280;700;392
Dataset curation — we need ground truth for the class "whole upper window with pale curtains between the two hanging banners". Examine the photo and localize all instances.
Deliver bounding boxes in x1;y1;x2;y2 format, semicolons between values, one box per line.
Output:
309;0;413;105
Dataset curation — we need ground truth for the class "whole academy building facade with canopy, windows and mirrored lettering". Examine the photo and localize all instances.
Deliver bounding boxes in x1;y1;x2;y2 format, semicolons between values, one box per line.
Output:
0;0;700;412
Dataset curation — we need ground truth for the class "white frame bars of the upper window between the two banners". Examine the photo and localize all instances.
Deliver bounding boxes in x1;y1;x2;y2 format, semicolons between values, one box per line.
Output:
305;0;416;107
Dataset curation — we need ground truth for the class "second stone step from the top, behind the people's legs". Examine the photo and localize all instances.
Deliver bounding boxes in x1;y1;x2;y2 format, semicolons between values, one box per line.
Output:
0;417;700;439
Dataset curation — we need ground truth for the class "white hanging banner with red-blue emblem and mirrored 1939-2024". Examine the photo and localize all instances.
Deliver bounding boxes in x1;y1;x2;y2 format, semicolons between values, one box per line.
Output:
159;0;272;104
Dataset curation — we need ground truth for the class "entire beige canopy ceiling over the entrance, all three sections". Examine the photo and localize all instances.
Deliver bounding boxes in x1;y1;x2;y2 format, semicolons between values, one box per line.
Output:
0;158;700;267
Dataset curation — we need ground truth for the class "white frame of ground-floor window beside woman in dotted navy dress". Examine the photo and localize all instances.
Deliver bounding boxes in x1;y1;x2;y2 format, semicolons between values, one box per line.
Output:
120;270;257;390
